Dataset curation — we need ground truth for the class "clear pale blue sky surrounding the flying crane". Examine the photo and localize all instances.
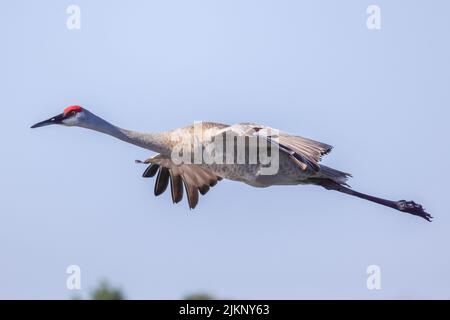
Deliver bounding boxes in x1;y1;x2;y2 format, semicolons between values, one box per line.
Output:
0;0;450;299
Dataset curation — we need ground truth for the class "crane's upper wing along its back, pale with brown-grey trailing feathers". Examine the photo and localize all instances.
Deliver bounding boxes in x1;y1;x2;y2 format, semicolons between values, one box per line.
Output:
214;123;333;172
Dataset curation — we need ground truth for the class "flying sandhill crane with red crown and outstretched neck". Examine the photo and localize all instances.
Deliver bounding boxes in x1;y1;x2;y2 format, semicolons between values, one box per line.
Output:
31;105;432;221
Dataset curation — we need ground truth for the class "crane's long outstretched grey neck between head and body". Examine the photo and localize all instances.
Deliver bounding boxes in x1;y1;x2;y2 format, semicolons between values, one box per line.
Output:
79;110;170;153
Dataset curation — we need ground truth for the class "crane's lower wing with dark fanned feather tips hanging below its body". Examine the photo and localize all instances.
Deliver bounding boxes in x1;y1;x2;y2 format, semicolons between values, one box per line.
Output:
137;155;222;209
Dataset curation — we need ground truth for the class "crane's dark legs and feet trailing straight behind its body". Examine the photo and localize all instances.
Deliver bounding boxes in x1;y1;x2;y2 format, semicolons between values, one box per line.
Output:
313;179;433;222
